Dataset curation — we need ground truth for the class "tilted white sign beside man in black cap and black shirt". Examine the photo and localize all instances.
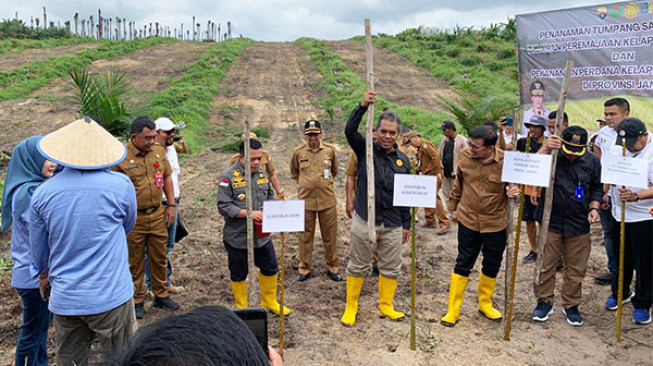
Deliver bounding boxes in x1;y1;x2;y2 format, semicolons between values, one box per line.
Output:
501;151;552;187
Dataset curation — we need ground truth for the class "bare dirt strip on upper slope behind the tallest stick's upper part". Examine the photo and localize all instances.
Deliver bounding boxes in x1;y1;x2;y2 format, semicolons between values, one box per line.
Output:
327;41;455;111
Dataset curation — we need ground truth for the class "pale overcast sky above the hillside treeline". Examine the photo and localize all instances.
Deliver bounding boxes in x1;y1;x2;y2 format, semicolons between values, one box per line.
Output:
0;0;605;41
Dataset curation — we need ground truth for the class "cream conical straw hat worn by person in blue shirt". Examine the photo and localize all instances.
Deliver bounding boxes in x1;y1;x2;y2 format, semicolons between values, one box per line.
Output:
38;117;127;170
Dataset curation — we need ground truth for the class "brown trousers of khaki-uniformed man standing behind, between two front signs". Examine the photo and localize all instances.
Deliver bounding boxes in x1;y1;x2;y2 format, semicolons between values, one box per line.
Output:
298;206;340;274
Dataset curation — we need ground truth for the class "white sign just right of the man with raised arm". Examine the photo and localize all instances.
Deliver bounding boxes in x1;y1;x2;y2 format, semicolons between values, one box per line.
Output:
392;174;438;208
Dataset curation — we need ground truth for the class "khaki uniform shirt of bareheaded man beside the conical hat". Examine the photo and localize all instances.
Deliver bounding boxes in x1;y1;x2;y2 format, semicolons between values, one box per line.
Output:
111;141;172;210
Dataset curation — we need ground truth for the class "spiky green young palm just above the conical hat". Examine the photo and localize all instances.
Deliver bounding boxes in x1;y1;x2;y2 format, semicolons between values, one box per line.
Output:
69;68;130;136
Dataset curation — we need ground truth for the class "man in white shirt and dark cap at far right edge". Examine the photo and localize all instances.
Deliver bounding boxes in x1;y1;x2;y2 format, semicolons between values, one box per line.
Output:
604;118;653;324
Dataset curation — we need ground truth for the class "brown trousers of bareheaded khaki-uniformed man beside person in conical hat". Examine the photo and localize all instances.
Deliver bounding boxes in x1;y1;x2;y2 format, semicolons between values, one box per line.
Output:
127;205;168;304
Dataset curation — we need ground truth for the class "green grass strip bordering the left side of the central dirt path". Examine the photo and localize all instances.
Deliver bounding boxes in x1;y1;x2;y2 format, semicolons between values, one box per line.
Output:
141;38;252;151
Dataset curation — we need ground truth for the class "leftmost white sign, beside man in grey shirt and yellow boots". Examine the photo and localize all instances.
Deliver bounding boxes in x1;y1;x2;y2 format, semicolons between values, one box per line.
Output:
263;200;304;233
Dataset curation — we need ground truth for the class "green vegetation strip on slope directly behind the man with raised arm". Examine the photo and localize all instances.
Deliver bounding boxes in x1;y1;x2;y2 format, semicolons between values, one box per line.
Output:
297;38;448;143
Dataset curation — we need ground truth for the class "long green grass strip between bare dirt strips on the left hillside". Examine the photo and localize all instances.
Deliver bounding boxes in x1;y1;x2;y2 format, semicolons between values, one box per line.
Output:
0;38;175;102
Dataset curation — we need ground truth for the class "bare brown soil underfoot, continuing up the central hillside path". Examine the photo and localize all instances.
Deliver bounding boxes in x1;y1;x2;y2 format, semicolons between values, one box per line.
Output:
0;43;653;366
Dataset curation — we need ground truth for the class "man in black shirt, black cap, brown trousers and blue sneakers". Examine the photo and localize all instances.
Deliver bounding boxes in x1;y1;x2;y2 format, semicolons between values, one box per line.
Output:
533;126;603;326
